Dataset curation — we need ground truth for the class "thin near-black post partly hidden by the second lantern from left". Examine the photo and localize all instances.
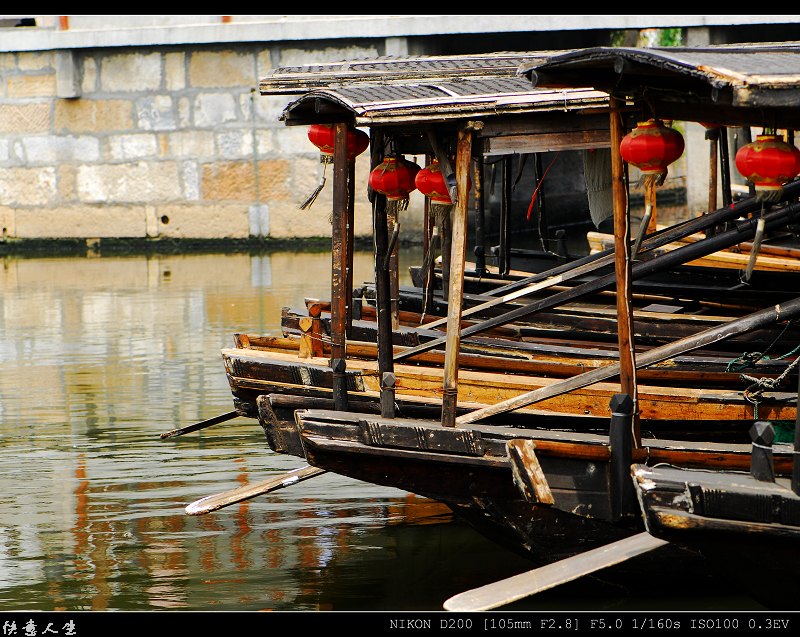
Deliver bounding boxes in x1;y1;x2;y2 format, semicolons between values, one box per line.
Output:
370;130;394;418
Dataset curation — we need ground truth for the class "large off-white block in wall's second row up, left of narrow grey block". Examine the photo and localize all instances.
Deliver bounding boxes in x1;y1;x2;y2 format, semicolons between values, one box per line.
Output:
76;162;182;203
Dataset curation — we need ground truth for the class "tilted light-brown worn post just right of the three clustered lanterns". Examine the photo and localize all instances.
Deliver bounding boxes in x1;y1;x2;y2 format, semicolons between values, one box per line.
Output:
442;128;472;427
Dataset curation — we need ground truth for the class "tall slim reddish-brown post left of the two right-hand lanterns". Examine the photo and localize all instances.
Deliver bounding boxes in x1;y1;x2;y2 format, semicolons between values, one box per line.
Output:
609;97;641;447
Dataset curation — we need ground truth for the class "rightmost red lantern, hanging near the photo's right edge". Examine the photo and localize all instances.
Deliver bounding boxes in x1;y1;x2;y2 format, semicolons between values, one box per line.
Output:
736;135;800;199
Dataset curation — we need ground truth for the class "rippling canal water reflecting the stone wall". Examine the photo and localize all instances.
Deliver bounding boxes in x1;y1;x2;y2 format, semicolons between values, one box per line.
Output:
0;252;764;611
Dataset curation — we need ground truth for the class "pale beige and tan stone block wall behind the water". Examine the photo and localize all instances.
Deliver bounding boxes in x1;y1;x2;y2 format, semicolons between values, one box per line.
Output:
0;43;421;241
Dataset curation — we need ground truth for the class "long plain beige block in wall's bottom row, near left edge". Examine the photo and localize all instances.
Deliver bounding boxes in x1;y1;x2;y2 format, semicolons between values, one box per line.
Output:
16;204;145;239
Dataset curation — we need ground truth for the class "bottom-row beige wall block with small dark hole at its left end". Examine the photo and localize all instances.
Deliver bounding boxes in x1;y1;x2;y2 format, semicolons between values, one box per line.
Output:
156;204;250;239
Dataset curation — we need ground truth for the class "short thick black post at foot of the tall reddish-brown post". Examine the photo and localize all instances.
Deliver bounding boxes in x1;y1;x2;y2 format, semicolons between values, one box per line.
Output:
608;394;636;522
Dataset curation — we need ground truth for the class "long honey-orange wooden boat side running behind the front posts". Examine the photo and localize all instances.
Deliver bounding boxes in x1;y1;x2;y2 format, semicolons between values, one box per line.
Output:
222;349;796;424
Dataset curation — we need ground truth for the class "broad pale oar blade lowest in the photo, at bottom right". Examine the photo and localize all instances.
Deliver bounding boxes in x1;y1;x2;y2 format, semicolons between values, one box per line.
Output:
444;533;668;612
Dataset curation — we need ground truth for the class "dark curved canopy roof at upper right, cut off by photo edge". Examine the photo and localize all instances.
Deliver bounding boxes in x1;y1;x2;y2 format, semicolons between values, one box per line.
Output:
519;42;800;128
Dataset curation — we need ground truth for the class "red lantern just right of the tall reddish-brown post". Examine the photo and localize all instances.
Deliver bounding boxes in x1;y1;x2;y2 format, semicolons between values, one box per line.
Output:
619;119;684;175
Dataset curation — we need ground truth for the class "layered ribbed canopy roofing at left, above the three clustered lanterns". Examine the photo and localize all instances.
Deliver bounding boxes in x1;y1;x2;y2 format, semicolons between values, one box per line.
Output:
260;51;609;154
